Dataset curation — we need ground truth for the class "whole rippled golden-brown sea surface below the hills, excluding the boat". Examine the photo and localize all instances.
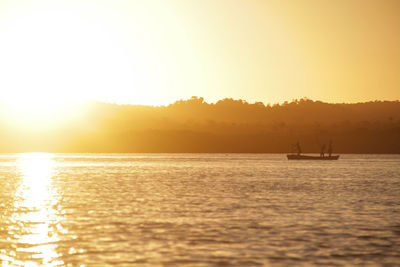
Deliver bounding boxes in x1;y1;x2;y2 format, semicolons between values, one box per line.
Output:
0;153;400;266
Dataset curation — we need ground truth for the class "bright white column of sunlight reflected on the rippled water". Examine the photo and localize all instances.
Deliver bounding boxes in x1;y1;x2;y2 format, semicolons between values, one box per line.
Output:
0;153;63;266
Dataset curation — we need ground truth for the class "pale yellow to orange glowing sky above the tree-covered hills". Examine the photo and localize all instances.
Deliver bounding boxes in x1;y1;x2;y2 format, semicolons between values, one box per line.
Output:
0;0;400;108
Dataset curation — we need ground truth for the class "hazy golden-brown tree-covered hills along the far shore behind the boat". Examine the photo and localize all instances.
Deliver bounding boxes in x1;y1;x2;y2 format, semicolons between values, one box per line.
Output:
0;97;400;153
